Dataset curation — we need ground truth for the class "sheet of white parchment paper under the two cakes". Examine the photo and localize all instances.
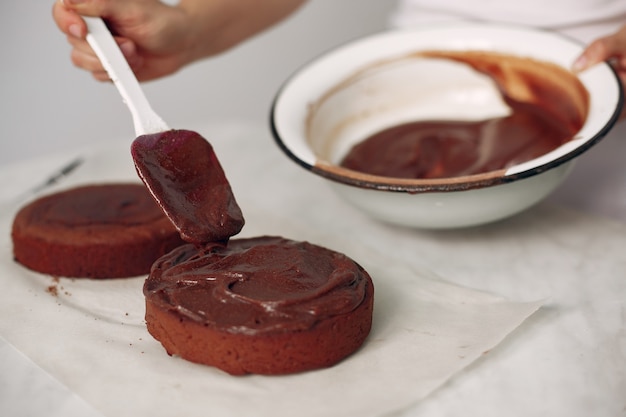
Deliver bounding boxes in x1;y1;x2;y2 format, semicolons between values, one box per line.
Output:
0;131;541;417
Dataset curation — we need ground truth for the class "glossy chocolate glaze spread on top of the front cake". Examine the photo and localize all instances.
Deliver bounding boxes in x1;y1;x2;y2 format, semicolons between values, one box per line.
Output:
144;236;371;335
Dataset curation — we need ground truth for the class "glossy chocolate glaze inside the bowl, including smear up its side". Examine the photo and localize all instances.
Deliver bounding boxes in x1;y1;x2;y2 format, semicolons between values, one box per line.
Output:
341;51;588;179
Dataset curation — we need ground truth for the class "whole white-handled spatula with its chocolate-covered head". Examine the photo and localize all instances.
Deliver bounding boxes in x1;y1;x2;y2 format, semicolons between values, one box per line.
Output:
85;18;244;244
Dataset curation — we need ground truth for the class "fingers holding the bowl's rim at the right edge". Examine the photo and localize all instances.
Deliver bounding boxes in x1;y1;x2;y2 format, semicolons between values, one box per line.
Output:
573;25;626;119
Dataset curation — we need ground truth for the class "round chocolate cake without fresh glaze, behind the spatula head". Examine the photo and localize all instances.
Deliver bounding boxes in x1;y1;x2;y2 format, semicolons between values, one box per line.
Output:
11;183;185;278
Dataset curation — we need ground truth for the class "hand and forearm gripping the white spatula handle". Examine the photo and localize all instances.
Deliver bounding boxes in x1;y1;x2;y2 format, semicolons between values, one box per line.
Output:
52;0;304;81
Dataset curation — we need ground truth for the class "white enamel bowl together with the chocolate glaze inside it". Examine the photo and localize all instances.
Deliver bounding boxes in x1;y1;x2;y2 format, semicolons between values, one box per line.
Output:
271;24;623;228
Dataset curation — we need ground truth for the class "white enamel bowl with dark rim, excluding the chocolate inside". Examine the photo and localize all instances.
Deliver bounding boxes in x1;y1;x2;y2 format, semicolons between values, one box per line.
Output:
271;24;623;228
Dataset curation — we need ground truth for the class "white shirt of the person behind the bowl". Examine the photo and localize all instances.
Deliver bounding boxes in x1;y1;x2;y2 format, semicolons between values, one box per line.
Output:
391;0;626;43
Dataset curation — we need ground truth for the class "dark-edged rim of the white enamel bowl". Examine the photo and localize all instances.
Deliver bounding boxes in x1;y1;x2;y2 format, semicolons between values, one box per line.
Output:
270;22;624;194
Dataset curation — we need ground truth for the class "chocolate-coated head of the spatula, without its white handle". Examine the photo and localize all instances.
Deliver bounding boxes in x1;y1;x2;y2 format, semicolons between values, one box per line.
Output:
131;130;244;244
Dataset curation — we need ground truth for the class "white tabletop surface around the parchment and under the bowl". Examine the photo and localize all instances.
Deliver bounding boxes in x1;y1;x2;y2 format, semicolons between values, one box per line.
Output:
0;123;626;417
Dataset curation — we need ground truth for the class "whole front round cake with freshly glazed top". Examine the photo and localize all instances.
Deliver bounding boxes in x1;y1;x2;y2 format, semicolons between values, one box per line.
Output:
144;236;374;375
